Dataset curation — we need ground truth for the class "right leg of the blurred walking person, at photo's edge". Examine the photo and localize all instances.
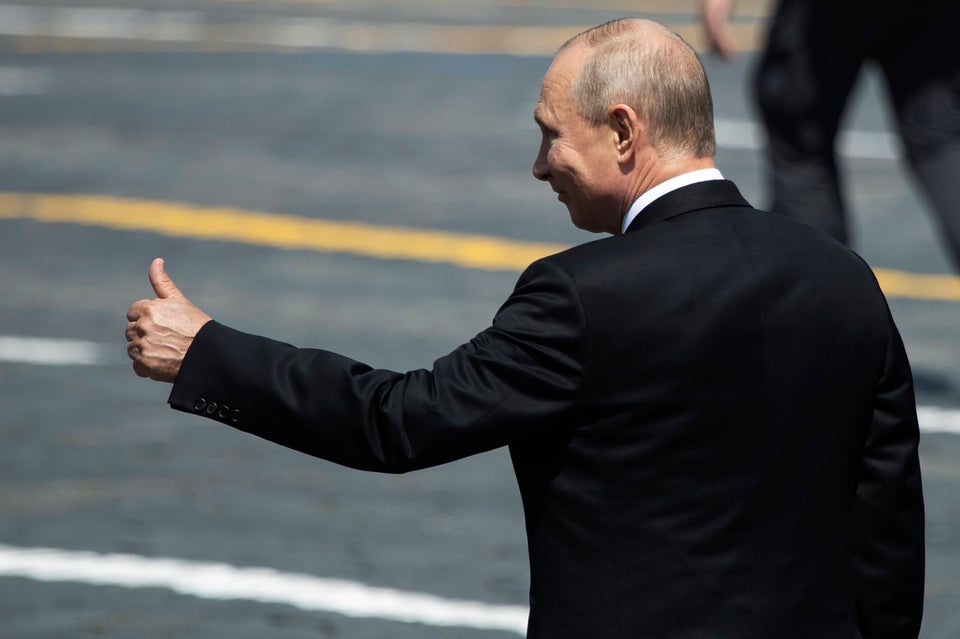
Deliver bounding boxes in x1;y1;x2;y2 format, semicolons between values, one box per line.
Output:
877;0;960;269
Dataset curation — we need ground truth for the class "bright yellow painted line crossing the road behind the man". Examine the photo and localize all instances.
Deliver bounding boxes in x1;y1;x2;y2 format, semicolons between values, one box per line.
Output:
0;193;960;302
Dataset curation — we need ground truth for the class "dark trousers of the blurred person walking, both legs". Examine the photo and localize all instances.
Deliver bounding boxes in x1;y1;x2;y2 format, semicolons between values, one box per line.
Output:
754;0;960;268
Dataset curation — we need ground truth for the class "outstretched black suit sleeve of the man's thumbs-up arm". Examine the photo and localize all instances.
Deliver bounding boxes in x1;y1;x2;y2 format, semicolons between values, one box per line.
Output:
169;260;585;472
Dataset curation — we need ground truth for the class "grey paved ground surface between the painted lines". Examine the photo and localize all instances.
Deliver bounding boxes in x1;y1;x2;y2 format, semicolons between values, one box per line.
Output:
0;0;960;639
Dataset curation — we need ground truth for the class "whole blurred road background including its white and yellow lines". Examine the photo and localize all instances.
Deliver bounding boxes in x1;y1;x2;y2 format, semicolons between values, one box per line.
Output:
0;0;960;639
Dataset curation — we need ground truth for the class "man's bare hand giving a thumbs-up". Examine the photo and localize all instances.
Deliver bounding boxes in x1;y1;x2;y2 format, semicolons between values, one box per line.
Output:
127;258;211;382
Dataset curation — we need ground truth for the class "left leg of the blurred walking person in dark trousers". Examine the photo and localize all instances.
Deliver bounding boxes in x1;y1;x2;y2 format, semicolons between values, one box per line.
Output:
753;0;864;243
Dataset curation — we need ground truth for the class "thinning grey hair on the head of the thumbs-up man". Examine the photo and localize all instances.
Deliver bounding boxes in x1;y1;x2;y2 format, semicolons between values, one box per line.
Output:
560;18;716;158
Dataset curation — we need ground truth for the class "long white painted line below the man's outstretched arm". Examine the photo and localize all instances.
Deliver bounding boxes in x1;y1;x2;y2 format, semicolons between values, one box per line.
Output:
0;545;528;635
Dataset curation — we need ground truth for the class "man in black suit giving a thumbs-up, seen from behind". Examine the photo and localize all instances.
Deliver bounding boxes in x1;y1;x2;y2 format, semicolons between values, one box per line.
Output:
127;20;924;639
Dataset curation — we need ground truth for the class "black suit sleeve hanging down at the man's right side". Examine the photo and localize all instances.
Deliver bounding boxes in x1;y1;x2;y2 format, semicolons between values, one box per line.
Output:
853;311;924;639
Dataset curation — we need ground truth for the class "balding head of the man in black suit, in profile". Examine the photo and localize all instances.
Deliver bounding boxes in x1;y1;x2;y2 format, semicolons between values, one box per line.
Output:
533;19;715;233
